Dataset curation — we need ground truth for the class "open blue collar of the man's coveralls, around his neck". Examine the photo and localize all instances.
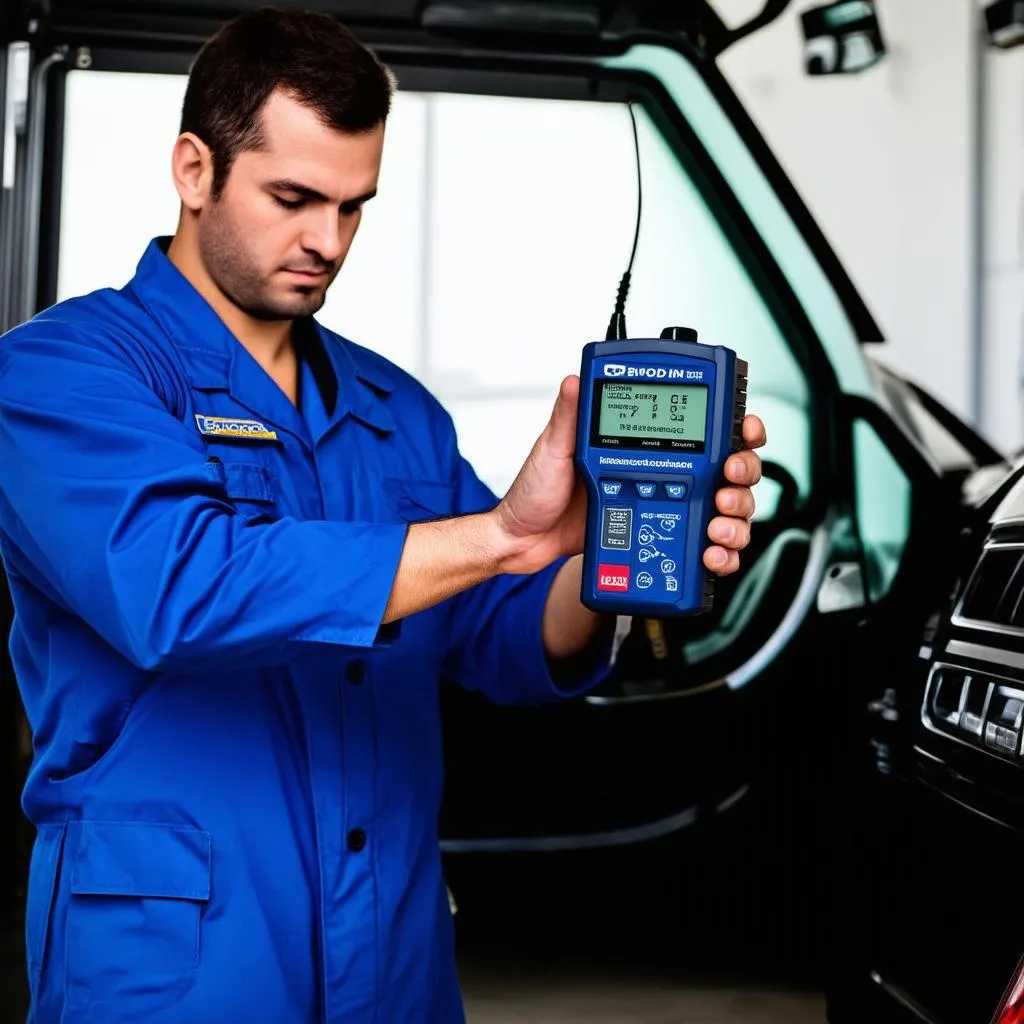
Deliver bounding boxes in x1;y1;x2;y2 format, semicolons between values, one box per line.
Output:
131;237;395;439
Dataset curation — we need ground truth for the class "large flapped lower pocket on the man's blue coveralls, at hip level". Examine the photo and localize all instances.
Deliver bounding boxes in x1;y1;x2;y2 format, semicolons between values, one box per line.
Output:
66;821;211;1020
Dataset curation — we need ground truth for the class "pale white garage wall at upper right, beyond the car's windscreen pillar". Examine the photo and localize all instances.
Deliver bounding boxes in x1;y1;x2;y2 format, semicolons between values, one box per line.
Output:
722;0;1024;446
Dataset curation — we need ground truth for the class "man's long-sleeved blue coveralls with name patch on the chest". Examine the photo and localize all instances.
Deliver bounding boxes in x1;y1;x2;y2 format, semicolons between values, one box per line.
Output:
0;239;606;1024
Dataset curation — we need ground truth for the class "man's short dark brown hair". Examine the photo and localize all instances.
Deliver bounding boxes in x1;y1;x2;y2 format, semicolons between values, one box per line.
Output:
181;7;394;199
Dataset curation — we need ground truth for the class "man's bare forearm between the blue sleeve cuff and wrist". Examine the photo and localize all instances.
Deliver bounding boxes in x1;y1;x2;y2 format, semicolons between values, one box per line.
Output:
383;513;511;624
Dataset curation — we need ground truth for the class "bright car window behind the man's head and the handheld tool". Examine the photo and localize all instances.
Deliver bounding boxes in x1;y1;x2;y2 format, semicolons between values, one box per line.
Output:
58;71;811;517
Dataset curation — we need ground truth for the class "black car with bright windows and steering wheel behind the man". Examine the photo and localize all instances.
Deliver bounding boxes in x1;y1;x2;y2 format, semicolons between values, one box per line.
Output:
0;0;1024;1024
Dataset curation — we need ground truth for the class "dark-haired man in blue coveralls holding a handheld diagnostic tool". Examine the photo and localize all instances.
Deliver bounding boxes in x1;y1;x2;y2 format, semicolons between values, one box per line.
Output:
0;10;764;1024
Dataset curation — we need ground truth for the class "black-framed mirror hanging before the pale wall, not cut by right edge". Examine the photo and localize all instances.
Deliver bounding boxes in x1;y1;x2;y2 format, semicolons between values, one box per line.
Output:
800;0;886;75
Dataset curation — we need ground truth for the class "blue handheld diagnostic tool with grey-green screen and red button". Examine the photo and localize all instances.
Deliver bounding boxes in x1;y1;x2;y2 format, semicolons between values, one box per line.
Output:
575;328;746;617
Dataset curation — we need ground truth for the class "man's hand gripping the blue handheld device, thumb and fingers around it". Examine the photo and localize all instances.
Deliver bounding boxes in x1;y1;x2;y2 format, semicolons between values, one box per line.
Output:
494;377;765;575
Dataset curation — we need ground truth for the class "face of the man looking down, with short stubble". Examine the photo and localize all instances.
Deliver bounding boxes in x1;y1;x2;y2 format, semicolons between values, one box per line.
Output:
199;92;384;319
